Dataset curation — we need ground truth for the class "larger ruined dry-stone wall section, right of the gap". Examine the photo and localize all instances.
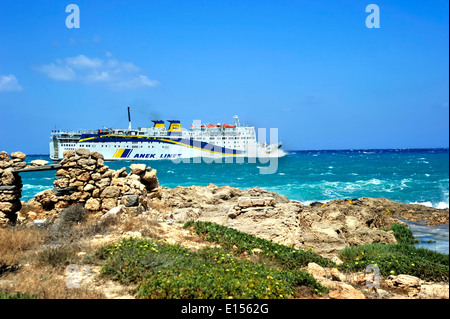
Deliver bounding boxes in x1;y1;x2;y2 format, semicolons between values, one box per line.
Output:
28;149;159;218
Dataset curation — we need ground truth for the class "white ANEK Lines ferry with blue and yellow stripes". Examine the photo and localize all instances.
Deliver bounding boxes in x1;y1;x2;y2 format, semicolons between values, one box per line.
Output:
50;108;284;161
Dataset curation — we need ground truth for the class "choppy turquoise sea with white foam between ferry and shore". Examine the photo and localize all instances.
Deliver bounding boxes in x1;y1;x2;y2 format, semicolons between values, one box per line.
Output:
21;148;449;254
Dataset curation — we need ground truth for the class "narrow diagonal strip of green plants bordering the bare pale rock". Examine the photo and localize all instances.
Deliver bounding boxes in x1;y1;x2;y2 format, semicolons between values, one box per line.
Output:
185;222;335;269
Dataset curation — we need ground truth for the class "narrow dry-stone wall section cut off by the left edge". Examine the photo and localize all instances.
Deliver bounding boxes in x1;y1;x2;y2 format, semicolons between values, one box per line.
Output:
0;152;27;226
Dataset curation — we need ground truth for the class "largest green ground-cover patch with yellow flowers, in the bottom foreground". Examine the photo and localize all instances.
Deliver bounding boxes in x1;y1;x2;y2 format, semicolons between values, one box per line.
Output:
98;238;327;299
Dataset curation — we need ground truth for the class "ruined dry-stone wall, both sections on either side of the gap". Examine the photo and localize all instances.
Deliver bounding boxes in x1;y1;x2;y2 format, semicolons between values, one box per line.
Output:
0;149;159;226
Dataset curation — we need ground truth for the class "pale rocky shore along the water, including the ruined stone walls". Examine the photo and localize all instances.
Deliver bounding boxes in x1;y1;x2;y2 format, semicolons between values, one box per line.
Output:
0;149;449;298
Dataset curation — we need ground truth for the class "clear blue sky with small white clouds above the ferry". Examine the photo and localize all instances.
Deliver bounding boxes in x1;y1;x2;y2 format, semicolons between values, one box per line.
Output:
0;0;449;154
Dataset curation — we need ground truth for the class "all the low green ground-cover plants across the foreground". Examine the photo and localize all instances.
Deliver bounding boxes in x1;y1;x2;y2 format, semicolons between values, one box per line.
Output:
96;221;449;299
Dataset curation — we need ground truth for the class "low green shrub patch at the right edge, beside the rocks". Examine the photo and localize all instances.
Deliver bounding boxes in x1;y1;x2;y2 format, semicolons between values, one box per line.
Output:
339;224;449;282
